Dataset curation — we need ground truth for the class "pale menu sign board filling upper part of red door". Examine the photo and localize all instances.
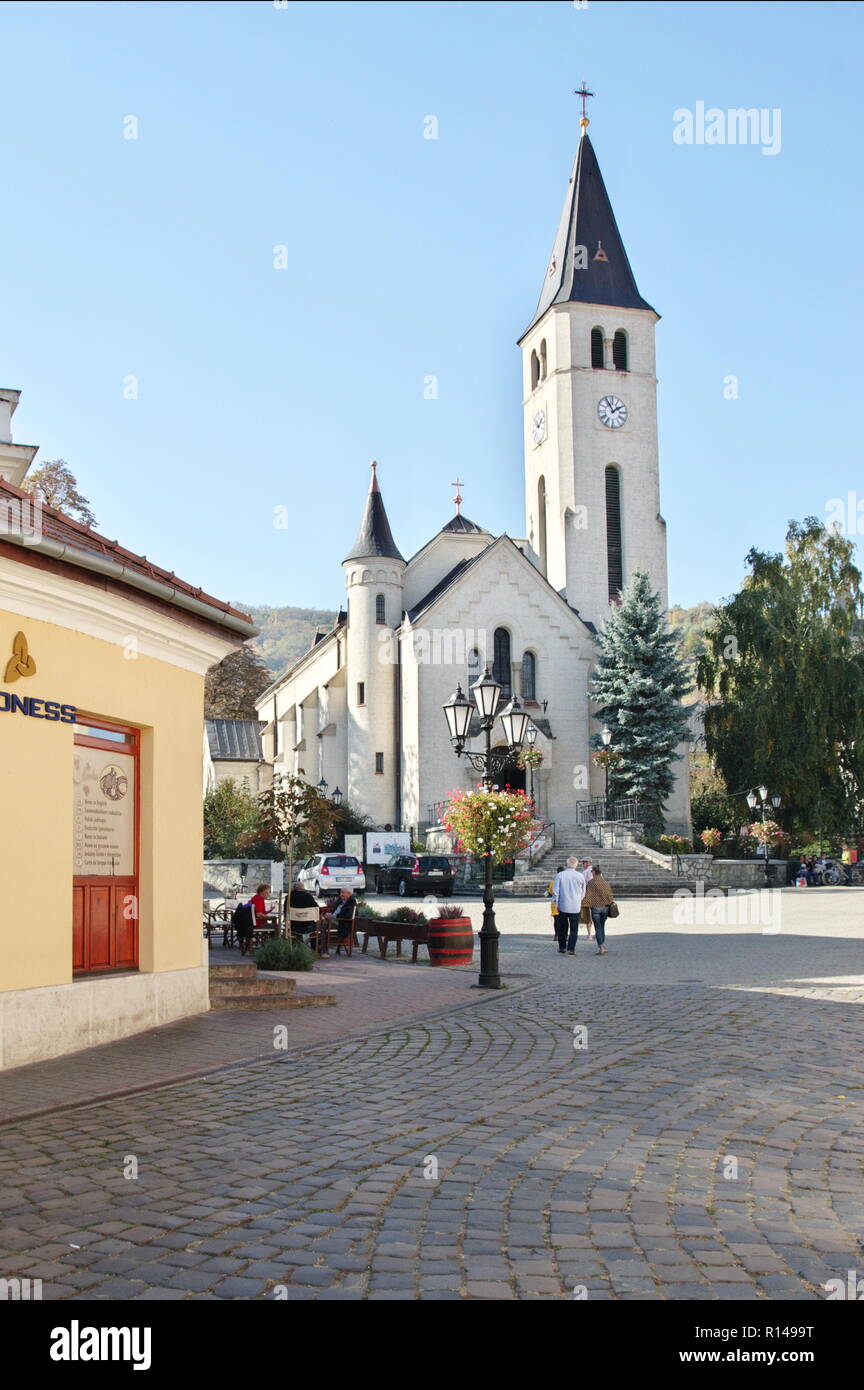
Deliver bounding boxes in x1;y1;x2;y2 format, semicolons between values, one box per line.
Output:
74;748;135;878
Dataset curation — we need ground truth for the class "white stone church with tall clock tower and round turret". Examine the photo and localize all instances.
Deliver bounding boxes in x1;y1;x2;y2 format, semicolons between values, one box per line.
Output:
257;114;689;837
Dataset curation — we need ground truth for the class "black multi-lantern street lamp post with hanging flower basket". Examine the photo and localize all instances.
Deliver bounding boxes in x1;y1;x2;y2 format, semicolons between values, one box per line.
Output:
443;667;528;990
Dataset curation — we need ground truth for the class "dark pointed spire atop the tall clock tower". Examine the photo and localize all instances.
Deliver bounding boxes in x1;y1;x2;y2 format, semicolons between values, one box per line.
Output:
525;130;656;332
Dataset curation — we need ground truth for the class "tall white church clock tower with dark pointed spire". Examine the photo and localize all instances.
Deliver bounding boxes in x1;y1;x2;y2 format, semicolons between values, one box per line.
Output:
520;107;668;626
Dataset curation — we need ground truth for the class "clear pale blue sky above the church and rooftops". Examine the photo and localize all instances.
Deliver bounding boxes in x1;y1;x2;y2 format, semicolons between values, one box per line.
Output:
0;0;864;607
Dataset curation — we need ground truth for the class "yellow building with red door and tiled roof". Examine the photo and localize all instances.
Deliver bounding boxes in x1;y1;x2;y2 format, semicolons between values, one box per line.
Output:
0;391;256;1068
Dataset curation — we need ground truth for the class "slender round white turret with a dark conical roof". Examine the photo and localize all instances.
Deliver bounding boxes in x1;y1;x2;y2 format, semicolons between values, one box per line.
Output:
342;464;406;827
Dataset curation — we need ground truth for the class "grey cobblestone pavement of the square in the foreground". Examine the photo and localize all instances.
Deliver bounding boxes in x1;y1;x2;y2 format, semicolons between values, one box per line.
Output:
0;905;864;1300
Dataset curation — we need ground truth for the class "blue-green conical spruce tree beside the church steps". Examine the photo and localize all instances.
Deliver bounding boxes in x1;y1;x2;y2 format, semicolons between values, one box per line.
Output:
590;574;690;835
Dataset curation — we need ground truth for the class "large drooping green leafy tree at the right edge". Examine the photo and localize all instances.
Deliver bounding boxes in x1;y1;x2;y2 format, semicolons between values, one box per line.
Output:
699;517;864;834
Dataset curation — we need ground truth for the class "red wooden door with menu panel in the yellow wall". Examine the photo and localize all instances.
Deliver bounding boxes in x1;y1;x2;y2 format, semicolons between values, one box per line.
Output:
72;714;139;974
